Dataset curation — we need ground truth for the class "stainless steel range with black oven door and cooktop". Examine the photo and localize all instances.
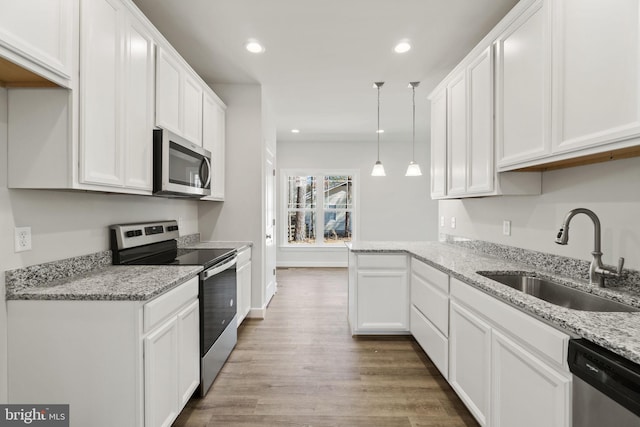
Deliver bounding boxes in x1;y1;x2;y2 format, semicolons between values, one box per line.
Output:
110;221;237;396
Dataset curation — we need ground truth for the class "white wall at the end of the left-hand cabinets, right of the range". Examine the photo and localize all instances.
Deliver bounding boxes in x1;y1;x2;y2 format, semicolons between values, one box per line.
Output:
198;84;265;309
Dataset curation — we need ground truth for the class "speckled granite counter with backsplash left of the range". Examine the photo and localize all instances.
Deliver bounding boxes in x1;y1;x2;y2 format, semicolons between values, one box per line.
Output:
5;251;202;301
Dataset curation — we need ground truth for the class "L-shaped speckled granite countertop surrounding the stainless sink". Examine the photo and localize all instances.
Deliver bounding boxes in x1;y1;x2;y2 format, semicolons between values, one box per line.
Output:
348;242;640;363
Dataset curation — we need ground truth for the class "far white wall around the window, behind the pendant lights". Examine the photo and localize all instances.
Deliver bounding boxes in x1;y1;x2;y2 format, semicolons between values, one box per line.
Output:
277;139;438;266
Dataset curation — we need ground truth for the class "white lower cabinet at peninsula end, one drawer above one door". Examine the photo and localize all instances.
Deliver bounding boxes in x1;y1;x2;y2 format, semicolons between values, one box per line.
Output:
349;253;409;335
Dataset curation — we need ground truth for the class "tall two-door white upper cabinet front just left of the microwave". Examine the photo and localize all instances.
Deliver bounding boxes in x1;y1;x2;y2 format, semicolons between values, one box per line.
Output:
79;0;153;192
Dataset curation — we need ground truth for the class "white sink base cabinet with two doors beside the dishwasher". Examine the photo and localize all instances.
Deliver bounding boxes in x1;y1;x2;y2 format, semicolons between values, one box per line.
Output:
449;278;571;427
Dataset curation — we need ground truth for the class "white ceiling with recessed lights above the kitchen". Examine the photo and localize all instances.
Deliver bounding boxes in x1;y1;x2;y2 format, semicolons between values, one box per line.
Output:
134;0;517;142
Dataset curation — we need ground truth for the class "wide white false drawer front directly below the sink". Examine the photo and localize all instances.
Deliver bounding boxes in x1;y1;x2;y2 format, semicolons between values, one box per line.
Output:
451;278;569;368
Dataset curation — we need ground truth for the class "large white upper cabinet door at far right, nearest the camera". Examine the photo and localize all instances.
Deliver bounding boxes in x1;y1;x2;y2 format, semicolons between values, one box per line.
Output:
551;0;640;152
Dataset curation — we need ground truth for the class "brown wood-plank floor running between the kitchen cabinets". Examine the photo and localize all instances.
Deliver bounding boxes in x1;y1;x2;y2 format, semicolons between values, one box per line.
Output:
174;268;478;427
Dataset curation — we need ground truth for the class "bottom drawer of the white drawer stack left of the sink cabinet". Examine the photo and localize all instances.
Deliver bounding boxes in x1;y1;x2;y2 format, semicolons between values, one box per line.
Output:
411;306;449;379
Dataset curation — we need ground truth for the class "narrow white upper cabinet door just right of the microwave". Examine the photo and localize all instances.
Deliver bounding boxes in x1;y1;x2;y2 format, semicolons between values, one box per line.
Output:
202;92;226;200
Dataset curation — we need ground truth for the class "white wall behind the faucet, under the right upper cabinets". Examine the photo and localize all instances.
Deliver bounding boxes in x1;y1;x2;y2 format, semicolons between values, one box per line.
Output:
440;158;640;269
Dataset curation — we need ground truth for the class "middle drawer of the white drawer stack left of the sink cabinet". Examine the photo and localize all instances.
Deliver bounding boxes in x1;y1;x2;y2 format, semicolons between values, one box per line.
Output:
411;272;449;337
